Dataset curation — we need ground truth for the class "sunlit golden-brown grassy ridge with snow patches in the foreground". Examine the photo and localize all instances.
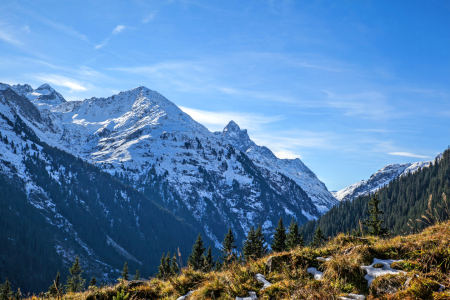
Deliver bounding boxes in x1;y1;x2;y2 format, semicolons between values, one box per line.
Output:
29;221;450;300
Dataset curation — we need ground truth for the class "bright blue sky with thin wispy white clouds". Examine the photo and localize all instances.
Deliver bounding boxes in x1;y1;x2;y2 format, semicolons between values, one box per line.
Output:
0;0;450;190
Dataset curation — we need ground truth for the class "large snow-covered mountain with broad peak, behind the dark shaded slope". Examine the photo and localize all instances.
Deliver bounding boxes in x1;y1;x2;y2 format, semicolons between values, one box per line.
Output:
2;81;337;247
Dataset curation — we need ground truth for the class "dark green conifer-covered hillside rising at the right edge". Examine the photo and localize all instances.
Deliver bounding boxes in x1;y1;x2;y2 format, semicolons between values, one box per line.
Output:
300;149;450;241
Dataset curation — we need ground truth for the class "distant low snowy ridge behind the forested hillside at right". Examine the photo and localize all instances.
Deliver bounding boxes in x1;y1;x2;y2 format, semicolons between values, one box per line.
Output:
332;158;441;201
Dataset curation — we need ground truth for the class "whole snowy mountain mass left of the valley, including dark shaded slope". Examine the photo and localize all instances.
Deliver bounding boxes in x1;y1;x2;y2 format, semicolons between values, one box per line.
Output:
0;84;338;289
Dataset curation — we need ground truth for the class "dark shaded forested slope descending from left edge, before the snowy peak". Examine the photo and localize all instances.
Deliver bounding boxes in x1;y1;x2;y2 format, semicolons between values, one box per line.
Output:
0;88;200;292
